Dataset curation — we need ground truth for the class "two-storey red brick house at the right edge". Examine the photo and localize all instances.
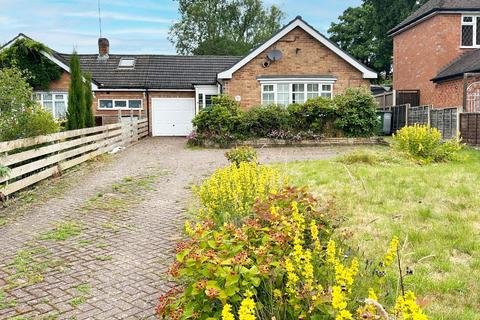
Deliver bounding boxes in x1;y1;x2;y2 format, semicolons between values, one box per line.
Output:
390;0;480;111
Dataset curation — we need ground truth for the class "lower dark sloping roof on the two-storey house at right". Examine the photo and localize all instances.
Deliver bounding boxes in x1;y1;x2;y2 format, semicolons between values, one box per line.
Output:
432;49;480;82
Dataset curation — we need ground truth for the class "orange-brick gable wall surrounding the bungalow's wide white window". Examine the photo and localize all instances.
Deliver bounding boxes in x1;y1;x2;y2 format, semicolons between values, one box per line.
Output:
224;28;370;107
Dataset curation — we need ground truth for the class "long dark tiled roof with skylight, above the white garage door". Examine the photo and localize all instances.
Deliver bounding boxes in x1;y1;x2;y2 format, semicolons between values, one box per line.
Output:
58;54;241;89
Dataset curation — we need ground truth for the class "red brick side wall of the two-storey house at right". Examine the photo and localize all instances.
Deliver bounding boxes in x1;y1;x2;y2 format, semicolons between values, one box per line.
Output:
393;14;471;106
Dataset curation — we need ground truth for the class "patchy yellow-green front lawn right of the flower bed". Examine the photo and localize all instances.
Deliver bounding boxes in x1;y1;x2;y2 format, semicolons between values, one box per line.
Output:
278;147;480;320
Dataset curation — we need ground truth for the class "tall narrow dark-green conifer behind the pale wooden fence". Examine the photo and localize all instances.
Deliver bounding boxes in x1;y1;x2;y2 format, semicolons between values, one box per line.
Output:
67;51;86;130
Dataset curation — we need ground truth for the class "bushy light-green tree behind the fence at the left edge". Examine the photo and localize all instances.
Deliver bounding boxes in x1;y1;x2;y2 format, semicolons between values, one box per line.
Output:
0;68;60;141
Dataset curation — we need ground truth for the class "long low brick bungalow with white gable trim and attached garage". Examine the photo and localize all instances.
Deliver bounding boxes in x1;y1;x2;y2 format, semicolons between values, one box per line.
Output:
1;17;377;136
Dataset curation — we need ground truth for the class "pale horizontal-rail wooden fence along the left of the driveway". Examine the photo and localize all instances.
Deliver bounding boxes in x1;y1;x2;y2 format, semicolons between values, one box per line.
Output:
0;119;148;198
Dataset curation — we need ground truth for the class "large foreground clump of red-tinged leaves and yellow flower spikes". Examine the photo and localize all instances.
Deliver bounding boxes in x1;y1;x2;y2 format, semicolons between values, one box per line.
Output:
157;188;427;320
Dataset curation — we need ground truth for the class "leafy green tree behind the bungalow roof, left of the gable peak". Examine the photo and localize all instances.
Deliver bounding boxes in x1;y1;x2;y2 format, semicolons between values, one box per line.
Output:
169;0;284;55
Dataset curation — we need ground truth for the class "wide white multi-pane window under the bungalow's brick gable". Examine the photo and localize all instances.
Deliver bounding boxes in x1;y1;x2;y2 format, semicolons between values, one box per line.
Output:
262;82;333;106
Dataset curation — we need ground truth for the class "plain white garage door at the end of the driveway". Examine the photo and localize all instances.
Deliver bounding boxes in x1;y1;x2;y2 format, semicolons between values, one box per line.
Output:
152;98;195;136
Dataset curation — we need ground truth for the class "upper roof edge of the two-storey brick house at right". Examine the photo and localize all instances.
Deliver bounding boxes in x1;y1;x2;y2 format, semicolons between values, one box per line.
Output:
388;0;480;35
